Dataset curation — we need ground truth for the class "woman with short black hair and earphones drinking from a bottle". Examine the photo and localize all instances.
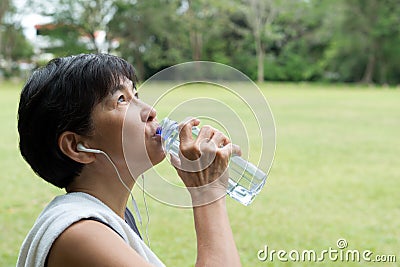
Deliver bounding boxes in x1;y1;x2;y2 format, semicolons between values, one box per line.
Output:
17;54;240;267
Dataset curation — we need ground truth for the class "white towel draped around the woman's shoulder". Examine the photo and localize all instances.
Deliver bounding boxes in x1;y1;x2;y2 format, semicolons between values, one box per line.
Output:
17;192;165;267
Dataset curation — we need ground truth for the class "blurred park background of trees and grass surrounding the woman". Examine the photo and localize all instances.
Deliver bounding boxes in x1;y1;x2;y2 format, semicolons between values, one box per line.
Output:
0;0;400;267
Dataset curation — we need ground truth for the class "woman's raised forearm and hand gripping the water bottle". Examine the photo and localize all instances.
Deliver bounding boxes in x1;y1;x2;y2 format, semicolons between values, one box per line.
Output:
171;119;241;267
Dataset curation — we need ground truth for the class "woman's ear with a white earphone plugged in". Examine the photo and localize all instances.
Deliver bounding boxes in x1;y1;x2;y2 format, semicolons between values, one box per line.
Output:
58;131;96;164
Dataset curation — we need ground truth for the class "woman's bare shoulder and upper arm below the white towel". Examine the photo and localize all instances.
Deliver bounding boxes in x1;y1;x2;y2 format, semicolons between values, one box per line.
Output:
47;220;151;267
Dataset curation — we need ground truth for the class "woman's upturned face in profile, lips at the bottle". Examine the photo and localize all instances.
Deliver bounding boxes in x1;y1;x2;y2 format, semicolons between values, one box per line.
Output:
89;78;165;177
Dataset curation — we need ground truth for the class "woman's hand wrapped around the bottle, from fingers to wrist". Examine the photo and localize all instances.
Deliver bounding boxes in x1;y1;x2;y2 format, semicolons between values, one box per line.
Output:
171;119;241;206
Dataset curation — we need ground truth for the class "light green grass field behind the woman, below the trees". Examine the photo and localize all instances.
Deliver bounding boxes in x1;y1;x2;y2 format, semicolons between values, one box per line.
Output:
0;81;400;266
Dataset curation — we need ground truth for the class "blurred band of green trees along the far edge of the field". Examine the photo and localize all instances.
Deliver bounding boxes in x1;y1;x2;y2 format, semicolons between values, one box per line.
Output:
0;0;400;85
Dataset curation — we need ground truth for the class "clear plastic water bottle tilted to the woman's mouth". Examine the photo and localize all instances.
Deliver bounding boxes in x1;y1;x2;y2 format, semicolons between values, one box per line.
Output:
157;118;267;206
